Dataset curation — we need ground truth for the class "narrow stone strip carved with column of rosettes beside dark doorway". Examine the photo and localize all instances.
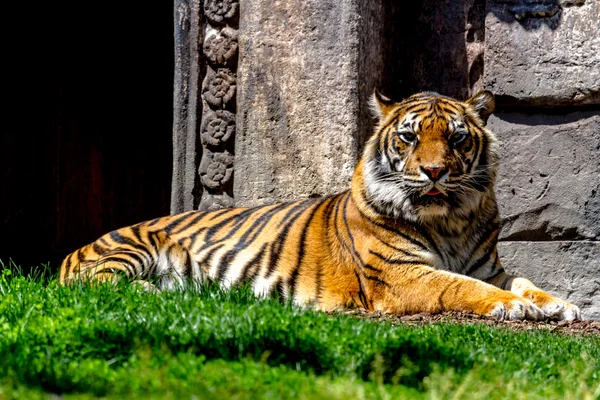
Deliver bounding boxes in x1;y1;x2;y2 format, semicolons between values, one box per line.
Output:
171;0;239;213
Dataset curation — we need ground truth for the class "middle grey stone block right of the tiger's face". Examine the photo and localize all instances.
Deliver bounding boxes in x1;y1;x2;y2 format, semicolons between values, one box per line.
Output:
488;111;600;241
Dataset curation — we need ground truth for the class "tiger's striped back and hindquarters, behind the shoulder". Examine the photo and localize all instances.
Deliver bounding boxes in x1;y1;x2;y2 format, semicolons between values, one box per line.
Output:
60;193;356;309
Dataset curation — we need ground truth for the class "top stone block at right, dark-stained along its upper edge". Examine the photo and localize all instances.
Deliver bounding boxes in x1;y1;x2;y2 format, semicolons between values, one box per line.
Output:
485;0;600;106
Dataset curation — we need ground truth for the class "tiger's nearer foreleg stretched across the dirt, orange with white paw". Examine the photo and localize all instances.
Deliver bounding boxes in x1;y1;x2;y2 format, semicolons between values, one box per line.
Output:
371;266;546;320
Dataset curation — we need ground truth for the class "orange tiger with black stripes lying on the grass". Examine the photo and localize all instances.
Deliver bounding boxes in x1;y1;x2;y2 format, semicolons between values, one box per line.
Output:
59;90;581;320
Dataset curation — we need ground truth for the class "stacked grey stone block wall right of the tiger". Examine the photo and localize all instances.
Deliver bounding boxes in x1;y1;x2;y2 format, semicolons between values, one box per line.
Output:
484;0;600;318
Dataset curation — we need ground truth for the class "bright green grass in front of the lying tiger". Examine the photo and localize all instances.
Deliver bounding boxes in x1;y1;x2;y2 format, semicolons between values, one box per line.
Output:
0;262;600;400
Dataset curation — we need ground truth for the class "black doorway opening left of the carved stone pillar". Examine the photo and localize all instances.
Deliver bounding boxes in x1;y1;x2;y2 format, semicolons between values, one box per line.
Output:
0;1;173;270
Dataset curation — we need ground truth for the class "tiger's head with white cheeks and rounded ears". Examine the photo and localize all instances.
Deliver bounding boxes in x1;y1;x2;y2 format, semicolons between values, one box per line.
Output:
361;91;498;222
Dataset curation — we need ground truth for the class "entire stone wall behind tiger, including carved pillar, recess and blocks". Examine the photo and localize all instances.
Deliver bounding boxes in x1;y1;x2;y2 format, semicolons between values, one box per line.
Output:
171;0;600;317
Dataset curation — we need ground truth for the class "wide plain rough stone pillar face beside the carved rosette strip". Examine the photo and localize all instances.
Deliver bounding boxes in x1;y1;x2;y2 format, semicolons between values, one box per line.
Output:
234;0;372;206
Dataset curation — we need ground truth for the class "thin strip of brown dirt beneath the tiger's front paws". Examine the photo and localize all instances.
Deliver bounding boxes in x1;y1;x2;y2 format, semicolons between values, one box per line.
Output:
346;310;600;336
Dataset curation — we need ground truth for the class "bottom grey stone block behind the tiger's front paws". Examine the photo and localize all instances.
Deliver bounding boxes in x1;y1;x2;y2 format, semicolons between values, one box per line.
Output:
498;241;600;319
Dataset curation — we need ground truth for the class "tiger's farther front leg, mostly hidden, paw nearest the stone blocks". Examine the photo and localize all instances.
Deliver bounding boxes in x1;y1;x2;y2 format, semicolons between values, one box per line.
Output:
488;270;581;321
